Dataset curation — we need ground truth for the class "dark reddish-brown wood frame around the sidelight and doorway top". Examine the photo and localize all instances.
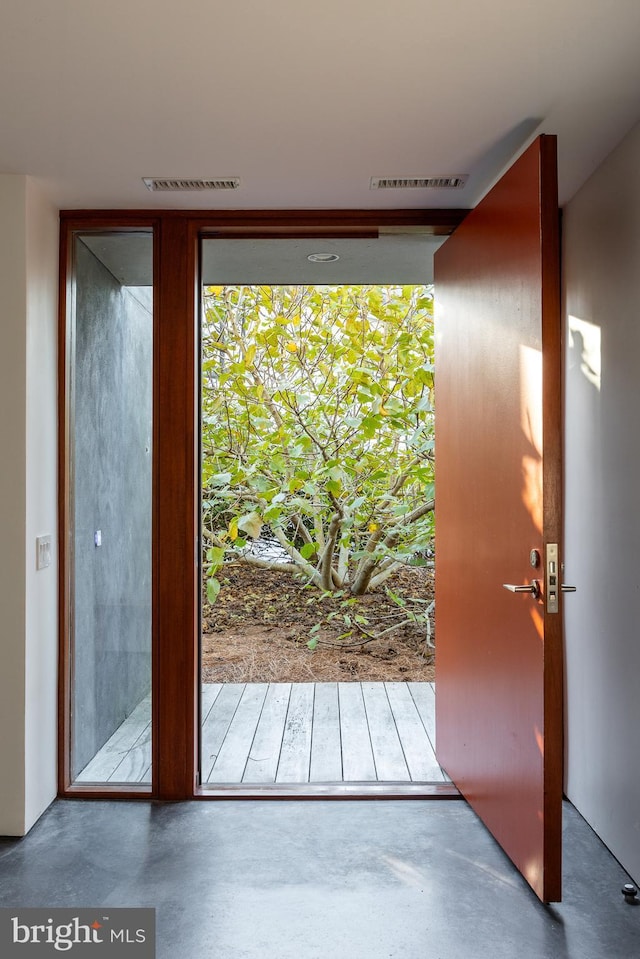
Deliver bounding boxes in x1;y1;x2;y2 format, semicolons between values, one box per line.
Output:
58;209;469;800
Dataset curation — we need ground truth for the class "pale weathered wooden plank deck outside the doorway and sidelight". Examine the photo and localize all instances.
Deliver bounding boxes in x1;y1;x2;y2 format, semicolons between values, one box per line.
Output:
76;683;448;787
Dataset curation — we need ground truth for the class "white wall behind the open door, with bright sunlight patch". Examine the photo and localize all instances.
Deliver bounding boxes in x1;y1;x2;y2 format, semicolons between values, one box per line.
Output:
564;120;640;880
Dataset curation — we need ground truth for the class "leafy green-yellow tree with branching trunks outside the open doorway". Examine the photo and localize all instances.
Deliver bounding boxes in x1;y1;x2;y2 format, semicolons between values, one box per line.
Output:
202;286;435;601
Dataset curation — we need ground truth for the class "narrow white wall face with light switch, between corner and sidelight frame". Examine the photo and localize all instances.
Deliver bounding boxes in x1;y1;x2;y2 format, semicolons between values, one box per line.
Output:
25;179;59;829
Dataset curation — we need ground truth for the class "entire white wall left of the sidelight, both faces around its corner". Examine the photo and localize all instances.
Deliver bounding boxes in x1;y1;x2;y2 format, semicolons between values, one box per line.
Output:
0;175;58;835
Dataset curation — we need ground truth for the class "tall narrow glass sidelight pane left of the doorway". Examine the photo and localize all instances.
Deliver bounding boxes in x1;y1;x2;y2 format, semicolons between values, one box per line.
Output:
68;230;153;784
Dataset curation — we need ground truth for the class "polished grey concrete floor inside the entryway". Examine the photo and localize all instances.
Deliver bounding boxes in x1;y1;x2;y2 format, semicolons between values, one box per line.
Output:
0;800;640;959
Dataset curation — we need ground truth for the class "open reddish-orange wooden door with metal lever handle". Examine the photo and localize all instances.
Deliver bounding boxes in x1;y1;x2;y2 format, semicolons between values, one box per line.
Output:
435;136;563;901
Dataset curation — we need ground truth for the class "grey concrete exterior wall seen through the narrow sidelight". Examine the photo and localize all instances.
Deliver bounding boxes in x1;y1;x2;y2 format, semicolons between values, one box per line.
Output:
73;239;153;775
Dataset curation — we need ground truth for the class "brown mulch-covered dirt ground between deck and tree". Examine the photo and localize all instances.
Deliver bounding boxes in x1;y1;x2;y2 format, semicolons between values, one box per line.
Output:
202;563;435;683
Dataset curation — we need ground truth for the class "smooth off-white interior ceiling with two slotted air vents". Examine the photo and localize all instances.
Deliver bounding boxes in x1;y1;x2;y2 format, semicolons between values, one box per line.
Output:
0;0;640;209
